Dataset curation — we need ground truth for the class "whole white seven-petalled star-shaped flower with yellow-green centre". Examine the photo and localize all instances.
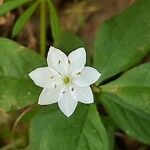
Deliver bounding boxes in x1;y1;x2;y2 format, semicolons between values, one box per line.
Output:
29;47;101;117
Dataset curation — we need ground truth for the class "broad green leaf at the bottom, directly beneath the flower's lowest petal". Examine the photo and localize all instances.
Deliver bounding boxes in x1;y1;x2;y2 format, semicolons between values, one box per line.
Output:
30;104;108;150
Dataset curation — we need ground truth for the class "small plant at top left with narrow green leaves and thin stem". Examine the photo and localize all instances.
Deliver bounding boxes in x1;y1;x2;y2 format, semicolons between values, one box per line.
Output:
0;0;61;56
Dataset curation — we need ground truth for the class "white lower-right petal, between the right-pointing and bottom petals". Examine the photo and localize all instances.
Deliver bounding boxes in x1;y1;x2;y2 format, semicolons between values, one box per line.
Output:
70;85;94;104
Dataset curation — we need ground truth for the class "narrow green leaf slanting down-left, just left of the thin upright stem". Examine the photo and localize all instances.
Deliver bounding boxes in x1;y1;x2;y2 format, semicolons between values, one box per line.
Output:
13;1;39;37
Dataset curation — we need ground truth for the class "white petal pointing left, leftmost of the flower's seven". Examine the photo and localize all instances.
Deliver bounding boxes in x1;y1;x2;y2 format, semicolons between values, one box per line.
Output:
29;67;62;88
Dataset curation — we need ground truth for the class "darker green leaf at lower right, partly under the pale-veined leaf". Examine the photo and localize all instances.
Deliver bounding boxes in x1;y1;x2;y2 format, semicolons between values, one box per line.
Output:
101;94;150;144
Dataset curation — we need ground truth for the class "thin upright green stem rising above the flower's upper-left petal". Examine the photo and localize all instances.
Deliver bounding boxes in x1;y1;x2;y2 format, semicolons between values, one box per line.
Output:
40;0;46;57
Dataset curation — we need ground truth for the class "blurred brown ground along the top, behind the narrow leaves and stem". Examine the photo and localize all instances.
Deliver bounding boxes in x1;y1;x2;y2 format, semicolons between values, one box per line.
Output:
0;0;135;51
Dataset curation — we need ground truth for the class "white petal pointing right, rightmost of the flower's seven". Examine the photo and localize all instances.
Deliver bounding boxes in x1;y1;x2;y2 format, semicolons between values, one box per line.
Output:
73;67;101;86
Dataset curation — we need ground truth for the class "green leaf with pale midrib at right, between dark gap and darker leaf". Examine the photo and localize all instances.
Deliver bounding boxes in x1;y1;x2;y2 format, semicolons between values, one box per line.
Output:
102;63;150;117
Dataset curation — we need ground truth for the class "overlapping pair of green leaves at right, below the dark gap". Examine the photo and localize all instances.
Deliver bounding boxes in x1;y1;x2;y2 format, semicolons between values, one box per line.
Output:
100;63;150;144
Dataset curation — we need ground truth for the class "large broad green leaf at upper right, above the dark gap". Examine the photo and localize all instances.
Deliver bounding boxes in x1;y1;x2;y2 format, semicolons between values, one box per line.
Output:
94;0;150;82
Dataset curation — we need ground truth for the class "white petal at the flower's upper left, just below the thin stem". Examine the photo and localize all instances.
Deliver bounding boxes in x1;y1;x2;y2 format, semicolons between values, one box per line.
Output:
47;46;68;74
